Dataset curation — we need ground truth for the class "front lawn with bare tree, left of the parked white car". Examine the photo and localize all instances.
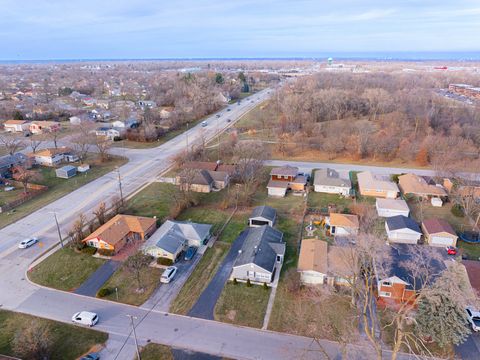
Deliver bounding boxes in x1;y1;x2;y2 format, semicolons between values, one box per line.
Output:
103;266;163;306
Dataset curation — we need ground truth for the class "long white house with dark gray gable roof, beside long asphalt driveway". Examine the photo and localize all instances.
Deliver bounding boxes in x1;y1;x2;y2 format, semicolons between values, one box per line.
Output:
230;225;285;285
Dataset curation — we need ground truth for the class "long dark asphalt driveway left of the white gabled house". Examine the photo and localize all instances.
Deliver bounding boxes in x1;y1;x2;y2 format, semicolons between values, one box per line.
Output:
188;230;248;320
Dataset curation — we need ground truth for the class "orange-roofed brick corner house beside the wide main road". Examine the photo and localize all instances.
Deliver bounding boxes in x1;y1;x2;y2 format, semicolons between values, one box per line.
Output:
82;214;157;252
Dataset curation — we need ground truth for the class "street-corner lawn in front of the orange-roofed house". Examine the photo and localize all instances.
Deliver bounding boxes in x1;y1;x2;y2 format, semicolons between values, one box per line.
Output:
28;247;105;291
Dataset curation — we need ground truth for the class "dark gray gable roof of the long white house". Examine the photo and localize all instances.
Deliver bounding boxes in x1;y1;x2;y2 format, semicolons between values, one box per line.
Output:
234;225;285;271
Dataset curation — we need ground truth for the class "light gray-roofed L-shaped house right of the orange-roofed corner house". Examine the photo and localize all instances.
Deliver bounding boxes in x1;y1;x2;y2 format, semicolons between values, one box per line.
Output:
143;220;212;262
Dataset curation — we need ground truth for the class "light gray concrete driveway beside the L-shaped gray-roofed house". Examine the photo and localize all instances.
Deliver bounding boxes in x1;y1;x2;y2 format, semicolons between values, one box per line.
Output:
141;251;203;312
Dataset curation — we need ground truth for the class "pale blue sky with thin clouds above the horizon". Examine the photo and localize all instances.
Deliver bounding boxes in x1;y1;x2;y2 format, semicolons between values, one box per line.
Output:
0;0;480;60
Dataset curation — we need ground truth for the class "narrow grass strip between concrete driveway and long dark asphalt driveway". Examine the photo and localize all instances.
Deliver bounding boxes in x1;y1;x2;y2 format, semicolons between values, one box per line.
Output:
170;242;230;315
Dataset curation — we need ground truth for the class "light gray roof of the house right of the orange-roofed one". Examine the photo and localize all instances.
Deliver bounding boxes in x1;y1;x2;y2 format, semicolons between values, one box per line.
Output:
144;220;212;253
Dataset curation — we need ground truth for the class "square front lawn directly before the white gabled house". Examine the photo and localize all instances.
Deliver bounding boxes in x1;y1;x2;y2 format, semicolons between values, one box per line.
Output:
214;282;271;328
